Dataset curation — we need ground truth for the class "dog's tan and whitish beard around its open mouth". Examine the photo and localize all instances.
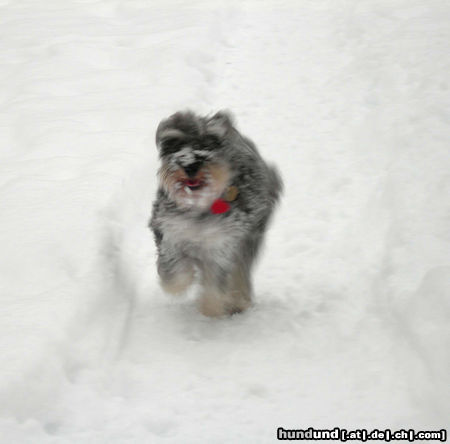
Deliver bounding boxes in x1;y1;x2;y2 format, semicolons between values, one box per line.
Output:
159;163;230;210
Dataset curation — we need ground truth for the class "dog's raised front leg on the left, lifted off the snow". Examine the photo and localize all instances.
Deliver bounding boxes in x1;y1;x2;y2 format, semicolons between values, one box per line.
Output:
157;249;194;294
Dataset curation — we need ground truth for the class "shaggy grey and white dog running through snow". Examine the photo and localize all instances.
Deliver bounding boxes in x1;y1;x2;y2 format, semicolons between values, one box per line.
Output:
150;111;282;316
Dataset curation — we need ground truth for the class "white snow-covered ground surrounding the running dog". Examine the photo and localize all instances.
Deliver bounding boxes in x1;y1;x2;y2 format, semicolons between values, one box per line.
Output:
0;0;450;444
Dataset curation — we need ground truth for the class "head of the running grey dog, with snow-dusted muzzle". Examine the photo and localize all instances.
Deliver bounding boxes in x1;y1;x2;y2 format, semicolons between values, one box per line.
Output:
156;111;232;210
